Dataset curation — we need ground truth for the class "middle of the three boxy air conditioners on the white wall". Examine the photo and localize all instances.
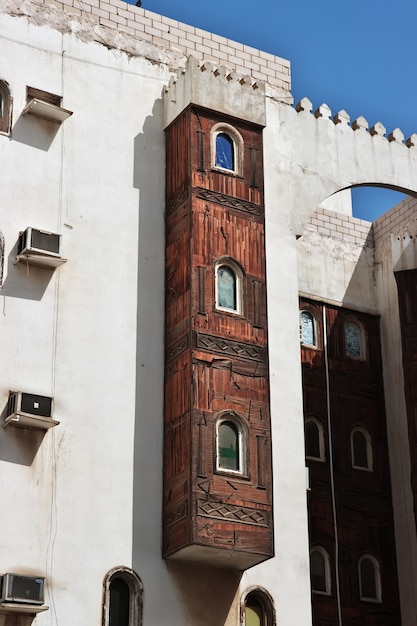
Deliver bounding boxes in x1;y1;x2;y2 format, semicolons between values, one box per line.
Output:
4;391;59;429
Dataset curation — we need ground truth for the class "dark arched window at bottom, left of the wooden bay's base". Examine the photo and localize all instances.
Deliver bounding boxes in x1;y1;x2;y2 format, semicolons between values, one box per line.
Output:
103;567;143;626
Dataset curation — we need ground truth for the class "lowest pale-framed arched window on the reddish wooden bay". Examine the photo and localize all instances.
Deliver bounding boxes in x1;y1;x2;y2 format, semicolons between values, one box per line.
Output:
216;414;246;474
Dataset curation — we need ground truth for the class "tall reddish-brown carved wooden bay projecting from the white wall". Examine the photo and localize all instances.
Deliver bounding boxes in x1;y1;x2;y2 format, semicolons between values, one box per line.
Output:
163;107;273;569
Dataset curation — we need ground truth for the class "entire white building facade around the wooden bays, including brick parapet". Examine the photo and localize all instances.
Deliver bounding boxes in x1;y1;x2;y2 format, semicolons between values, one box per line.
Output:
0;0;417;626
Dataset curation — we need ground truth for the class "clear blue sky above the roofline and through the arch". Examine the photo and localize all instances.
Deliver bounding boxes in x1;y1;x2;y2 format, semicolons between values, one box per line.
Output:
126;0;417;220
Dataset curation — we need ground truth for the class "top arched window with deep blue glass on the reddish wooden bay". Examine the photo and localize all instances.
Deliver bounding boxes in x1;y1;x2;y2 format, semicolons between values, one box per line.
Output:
211;122;243;175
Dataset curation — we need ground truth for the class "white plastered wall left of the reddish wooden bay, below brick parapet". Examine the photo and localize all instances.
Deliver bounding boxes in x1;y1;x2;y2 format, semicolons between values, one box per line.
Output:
0;15;170;625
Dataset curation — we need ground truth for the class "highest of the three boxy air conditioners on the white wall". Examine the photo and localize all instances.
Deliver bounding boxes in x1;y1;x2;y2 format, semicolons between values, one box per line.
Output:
16;226;67;268
